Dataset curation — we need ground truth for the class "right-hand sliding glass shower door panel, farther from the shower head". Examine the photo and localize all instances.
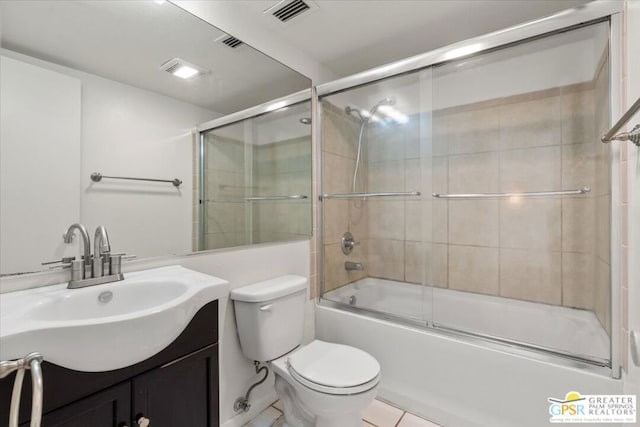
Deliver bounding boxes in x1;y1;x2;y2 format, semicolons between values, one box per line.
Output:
433;22;611;364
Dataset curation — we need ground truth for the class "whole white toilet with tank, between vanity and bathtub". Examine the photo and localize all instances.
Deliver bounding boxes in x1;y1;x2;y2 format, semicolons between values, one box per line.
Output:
231;275;380;427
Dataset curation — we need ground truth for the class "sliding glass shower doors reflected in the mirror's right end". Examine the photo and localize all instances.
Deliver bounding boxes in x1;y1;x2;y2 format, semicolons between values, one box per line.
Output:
199;101;311;250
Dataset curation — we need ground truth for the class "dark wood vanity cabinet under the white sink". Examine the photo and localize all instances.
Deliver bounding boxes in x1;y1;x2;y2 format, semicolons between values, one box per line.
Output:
0;301;219;427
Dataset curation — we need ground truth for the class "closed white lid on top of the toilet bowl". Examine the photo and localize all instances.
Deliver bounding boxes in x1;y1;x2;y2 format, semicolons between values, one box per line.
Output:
288;340;380;388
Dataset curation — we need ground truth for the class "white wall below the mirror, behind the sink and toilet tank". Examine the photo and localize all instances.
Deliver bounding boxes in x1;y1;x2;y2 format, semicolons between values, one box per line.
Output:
0;240;313;427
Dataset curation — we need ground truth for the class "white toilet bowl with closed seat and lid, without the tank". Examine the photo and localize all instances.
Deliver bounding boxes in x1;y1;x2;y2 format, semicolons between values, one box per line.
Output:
271;340;380;427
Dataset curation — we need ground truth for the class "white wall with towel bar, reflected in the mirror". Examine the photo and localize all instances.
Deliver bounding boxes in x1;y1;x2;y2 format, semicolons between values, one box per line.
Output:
2;50;220;271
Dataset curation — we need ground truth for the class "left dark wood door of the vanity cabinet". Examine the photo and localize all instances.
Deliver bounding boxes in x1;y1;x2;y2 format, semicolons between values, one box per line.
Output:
28;381;131;427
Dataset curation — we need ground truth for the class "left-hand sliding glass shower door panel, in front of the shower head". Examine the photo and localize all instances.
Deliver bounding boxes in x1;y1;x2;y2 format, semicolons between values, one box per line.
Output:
321;69;433;324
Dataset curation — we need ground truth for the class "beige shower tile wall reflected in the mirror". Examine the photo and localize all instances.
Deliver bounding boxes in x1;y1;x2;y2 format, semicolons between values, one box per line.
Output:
199;133;311;249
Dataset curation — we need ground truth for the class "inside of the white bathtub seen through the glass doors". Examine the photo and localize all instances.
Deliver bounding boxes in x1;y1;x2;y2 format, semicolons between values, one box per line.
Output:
324;277;610;362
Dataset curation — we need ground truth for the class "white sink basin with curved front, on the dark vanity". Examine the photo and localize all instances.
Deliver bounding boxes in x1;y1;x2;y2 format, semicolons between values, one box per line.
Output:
0;266;229;372
